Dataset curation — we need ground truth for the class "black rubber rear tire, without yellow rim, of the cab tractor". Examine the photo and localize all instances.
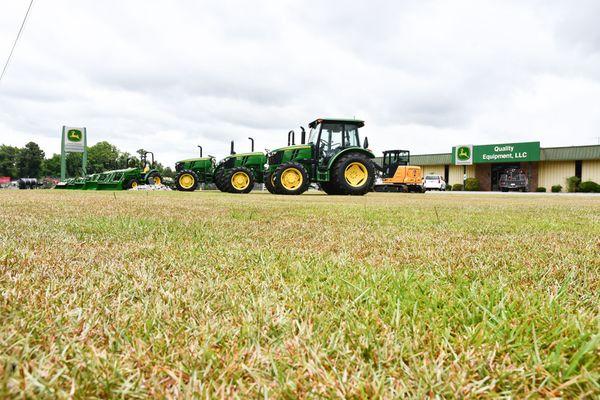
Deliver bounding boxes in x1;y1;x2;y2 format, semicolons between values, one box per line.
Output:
329;153;375;196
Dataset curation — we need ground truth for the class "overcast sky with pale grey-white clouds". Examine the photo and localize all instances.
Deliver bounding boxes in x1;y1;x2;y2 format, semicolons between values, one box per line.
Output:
0;0;600;165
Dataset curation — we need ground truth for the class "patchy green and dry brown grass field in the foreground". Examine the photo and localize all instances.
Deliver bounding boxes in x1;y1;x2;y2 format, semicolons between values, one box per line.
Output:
0;190;600;398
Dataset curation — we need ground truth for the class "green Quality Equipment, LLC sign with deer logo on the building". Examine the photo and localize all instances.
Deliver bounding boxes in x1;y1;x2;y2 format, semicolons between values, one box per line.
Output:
452;142;540;165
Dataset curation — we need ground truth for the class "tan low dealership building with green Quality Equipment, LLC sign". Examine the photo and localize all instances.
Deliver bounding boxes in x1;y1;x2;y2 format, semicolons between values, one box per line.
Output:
410;142;600;191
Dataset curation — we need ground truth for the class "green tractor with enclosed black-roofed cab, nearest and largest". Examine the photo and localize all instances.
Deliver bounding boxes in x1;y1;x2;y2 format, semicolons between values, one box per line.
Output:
264;118;375;195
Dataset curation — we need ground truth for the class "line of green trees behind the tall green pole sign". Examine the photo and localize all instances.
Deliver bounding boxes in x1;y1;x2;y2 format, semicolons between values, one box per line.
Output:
0;141;173;179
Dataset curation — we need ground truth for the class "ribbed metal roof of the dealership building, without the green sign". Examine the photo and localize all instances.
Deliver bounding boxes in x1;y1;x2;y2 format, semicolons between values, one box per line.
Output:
375;145;600;165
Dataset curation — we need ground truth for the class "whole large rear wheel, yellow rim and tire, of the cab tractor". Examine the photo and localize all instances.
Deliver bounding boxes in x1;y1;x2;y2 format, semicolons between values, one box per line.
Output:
330;153;375;196
